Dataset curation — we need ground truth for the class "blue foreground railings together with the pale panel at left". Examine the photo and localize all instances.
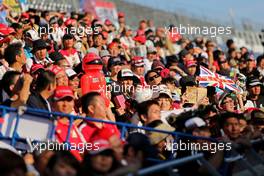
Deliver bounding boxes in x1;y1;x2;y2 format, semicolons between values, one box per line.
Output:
0;106;264;175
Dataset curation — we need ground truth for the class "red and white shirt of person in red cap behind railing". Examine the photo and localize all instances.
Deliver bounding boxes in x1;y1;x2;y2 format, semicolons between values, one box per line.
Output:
55;120;85;161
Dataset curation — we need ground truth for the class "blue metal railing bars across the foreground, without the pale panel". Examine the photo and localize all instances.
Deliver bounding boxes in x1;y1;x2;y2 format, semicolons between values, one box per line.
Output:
0;106;263;175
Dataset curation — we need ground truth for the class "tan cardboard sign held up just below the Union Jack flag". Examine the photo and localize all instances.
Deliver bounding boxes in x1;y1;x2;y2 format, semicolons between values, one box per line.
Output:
186;87;207;104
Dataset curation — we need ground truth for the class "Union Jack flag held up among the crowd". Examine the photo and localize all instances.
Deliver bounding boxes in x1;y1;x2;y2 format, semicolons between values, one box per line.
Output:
197;66;241;92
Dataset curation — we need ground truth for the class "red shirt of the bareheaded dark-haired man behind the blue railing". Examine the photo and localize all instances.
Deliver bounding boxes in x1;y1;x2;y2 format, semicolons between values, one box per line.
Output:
79;121;121;142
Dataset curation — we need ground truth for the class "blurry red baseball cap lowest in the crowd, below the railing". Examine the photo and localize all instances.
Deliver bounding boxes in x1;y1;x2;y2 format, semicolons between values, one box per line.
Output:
89;139;113;155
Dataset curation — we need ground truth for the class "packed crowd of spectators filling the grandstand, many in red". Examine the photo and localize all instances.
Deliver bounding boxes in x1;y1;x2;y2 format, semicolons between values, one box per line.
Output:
0;6;264;176
